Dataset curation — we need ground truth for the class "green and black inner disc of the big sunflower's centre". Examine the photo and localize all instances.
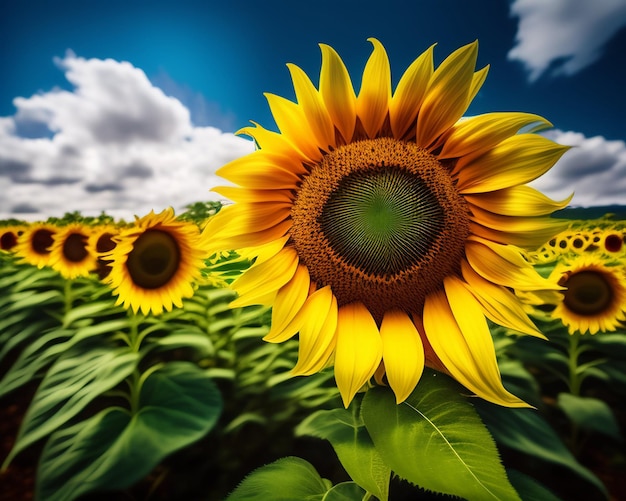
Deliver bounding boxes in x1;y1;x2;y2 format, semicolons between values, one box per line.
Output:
320;167;443;276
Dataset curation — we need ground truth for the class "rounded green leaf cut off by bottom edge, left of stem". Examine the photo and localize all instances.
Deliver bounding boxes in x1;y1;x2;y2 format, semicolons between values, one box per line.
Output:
226;456;330;501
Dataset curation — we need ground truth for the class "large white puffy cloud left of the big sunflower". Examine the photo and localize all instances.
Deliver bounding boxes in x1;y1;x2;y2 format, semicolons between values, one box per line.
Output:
0;52;253;219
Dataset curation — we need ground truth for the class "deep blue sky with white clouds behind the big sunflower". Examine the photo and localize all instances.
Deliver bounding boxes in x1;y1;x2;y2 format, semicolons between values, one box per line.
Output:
0;0;626;219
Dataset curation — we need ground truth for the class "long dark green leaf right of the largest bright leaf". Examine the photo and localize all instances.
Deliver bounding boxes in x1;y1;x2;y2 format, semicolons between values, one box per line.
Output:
476;401;606;495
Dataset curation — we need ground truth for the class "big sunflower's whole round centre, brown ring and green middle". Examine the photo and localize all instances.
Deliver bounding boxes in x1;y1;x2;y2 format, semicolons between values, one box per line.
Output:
291;138;469;320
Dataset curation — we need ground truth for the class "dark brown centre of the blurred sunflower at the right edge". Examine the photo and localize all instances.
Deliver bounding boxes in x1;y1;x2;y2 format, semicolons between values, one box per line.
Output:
563;270;613;315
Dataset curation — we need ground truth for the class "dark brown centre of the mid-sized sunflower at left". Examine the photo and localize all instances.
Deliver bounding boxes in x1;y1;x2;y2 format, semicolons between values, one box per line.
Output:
126;230;180;289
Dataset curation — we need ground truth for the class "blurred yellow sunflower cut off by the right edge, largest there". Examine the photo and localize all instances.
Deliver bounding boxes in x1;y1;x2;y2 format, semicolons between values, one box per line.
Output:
549;254;626;334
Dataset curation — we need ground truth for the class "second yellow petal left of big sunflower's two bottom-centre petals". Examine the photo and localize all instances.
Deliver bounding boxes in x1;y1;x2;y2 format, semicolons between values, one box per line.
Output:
263;265;311;343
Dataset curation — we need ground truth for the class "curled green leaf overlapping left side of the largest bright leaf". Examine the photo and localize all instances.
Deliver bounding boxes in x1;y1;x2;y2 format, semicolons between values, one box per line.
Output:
296;409;391;501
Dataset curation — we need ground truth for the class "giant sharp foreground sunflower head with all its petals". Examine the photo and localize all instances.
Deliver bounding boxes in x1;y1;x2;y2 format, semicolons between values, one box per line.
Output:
203;39;568;406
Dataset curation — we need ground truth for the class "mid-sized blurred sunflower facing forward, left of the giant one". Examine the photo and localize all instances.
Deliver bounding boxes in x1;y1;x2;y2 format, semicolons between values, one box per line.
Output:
102;208;205;314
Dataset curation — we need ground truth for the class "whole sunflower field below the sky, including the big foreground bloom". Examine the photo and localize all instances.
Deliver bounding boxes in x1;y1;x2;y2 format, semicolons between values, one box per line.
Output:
0;39;626;501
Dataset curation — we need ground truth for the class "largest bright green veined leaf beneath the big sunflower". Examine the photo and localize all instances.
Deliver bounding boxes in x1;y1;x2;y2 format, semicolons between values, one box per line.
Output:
362;370;520;500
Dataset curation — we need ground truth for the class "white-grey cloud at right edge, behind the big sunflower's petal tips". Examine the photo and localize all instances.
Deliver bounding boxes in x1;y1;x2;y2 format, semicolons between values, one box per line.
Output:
531;129;626;207
